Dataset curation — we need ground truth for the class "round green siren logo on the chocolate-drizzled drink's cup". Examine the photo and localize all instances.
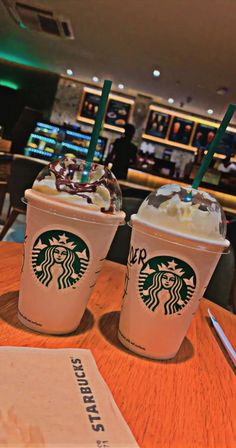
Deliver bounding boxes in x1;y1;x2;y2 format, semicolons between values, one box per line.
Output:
32;230;89;289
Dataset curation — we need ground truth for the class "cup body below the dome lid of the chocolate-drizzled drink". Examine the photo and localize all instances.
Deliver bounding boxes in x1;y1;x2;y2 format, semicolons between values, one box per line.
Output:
18;190;125;334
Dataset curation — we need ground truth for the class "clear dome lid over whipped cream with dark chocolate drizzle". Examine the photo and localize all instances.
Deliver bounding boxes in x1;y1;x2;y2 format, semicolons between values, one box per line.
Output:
32;157;122;213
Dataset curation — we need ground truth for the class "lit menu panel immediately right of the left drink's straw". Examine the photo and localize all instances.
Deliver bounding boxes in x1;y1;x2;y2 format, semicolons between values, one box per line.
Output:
105;99;131;127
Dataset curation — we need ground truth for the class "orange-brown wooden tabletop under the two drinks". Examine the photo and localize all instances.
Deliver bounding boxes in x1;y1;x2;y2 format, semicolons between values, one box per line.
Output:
0;243;236;448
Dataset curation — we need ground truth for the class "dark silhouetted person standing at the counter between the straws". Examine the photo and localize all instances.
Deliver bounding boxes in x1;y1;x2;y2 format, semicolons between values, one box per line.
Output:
105;124;138;179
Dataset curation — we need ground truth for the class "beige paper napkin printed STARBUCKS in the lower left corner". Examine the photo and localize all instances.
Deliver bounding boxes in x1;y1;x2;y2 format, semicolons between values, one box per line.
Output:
0;347;138;448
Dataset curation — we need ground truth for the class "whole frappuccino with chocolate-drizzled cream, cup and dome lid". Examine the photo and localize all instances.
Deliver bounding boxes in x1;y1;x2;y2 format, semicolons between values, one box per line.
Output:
18;158;124;334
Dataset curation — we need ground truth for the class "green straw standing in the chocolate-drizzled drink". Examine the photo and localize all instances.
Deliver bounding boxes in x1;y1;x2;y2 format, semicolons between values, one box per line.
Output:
81;79;112;182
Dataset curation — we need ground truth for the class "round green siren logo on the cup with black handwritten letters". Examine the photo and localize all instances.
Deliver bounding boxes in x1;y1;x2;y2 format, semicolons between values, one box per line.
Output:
139;256;196;315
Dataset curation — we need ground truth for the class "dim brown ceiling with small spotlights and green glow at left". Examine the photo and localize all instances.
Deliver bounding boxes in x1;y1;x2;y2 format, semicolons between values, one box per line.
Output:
0;0;236;122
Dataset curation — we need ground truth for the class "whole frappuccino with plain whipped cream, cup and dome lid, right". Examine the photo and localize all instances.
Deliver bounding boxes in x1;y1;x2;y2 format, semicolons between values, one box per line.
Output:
118;184;229;359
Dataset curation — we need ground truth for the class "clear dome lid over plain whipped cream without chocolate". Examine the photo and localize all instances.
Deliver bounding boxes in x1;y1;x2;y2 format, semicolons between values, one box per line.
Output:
137;184;226;240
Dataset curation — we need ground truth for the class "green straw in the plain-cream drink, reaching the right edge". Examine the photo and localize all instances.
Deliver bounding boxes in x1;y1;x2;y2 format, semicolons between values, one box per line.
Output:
192;104;236;189
